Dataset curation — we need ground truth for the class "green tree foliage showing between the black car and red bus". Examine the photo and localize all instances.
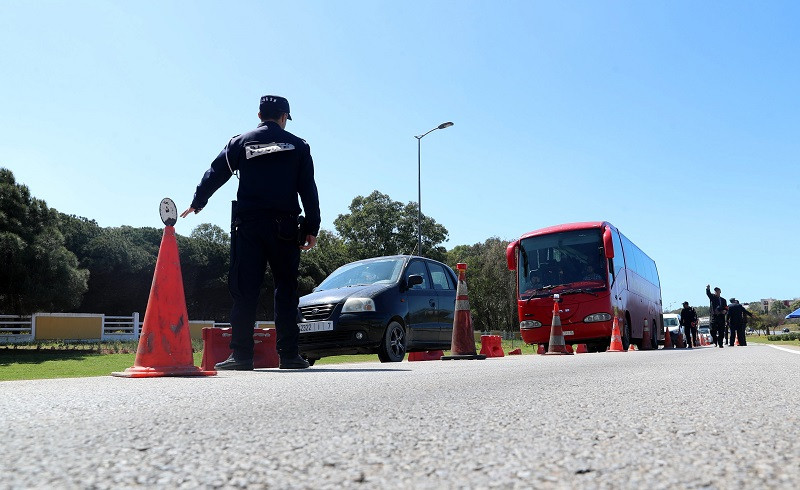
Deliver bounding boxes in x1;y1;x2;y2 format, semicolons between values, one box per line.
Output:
447;237;519;330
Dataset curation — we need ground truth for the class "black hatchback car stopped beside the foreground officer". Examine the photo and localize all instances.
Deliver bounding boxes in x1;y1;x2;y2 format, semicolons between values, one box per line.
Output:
298;255;458;363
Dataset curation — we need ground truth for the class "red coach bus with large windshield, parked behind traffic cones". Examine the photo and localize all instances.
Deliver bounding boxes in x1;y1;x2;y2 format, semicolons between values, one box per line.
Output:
506;221;663;352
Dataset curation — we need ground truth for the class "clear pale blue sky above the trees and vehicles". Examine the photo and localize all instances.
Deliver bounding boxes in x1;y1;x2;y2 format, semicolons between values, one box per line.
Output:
0;0;800;308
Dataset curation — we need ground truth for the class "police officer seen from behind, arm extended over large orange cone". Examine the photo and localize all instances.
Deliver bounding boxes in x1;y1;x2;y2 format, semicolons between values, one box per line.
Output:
181;95;320;371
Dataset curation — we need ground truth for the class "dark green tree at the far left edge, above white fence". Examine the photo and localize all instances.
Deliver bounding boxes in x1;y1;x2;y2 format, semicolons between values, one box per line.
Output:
0;168;88;314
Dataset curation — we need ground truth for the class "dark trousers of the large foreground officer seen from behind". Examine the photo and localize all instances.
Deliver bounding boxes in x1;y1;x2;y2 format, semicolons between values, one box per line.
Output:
228;216;300;359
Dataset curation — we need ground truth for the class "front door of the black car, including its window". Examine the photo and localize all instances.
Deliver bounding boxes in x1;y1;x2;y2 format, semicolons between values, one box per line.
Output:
405;259;439;346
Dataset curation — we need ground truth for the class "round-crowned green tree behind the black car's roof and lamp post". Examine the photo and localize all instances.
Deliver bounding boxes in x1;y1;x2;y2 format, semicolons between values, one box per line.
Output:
334;191;448;261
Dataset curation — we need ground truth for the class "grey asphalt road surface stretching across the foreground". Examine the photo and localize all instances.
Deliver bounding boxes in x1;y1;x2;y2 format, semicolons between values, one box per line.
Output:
0;345;800;489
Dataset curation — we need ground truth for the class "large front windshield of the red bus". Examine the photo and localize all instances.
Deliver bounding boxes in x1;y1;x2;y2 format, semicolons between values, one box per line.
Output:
518;229;608;298
